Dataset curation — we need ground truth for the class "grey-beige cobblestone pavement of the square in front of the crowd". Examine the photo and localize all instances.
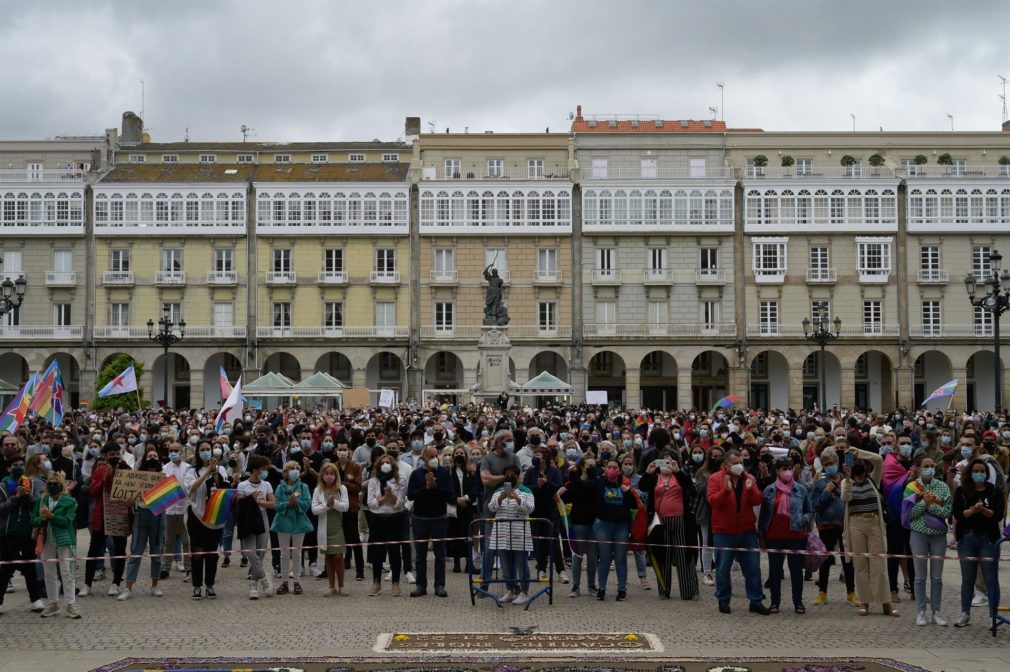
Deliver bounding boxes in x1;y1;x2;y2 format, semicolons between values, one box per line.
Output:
0;533;1010;672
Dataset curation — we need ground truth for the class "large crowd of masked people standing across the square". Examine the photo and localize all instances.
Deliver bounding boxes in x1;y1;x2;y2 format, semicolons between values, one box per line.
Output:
0;396;1010;627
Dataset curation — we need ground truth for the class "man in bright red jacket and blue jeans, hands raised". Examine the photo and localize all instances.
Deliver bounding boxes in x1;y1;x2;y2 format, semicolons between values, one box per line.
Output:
707;450;770;615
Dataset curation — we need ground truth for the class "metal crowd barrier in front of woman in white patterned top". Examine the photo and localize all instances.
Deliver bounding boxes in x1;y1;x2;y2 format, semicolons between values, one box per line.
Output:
468;517;558;610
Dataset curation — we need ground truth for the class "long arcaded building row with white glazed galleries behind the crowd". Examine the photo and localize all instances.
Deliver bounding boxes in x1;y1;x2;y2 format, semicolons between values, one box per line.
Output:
0;109;1010;409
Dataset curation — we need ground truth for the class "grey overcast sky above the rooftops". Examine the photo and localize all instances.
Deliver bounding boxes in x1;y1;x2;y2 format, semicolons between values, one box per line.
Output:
0;0;1010;141
